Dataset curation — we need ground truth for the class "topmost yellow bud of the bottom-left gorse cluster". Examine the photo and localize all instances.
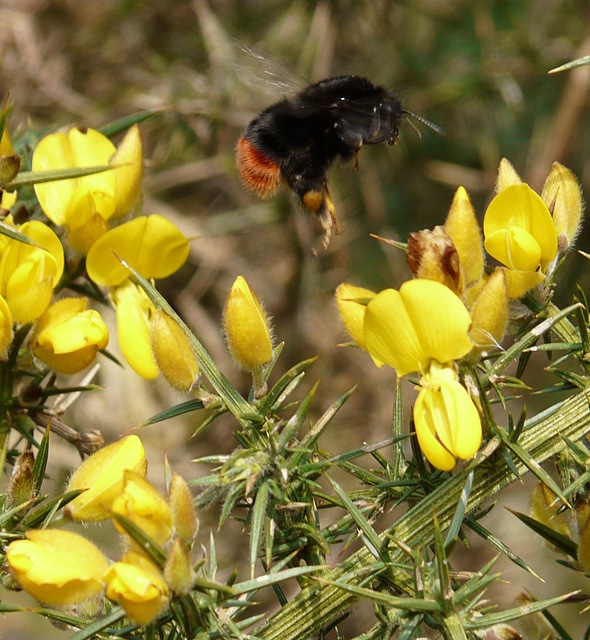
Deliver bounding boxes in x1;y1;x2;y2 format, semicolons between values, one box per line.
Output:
64;436;147;522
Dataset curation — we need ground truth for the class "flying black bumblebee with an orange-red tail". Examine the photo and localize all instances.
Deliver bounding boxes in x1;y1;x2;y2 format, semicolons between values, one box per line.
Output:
236;76;437;253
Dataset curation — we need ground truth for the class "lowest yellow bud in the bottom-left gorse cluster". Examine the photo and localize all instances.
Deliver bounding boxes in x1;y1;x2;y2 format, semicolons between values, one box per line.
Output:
104;551;170;625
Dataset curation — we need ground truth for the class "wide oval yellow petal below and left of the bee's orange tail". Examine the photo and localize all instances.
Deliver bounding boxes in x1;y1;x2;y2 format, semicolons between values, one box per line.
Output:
86;215;189;286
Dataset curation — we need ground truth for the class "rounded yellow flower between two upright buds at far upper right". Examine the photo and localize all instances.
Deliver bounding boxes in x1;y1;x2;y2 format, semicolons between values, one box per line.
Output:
484;184;557;273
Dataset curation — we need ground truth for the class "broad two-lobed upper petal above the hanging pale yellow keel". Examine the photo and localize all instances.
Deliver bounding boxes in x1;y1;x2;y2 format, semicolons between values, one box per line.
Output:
364;280;473;376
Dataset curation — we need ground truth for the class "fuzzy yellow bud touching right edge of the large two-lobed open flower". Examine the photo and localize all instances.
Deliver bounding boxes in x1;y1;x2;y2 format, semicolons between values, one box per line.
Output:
468;269;508;349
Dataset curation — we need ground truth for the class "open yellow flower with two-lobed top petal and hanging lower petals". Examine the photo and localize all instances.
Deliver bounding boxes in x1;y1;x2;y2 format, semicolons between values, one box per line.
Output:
339;279;482;470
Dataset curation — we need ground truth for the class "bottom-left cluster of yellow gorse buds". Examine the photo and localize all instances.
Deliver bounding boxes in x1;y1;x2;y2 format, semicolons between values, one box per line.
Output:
6;436;198;625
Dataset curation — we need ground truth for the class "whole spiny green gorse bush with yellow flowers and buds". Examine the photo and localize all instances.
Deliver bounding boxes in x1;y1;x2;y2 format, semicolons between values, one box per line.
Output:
0;76;590;640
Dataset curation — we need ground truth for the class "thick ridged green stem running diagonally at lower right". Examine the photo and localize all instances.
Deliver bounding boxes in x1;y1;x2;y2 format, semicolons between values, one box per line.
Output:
252;390;590;640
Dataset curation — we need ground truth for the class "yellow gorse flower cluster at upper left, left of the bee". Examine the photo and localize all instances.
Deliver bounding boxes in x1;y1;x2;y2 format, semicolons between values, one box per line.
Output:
0;109;189;378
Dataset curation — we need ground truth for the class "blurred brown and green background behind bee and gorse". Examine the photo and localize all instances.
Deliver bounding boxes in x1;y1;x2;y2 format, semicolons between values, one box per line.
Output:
0;0;590;637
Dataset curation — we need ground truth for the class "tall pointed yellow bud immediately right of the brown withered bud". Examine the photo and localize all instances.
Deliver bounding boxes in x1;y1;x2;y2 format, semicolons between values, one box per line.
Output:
444;187;484;289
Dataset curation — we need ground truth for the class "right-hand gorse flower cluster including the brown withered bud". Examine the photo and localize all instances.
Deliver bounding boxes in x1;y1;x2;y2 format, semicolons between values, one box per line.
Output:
336;160;582;470
